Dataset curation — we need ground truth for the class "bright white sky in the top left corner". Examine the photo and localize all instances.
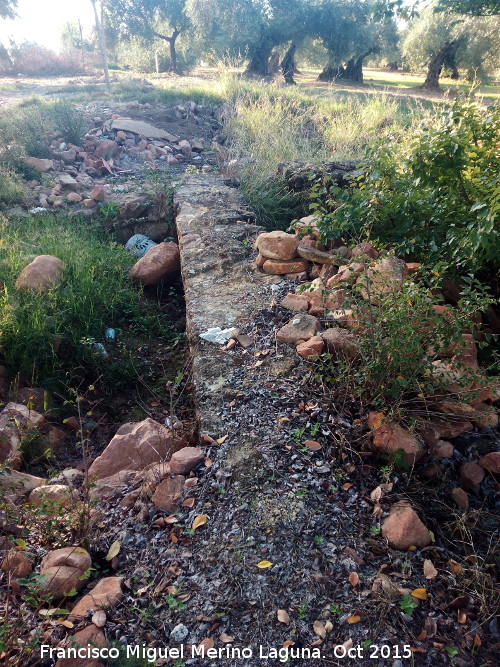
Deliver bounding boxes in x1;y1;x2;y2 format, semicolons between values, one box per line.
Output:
0;0;93;51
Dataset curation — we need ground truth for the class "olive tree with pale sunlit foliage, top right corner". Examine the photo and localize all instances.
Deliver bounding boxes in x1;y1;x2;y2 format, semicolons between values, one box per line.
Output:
403;6;499;90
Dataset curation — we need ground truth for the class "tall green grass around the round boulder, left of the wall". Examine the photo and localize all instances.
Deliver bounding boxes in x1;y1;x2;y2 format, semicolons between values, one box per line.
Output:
0;215;140;386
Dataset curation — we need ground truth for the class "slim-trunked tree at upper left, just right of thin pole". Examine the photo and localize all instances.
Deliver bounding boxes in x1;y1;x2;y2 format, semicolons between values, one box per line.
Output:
107;0;190;73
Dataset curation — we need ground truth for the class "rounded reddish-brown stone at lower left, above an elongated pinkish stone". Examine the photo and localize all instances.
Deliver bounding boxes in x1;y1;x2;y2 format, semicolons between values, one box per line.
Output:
40;547;92;599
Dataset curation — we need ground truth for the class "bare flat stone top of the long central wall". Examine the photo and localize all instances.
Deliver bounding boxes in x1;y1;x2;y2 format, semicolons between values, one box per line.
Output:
174;174;280;437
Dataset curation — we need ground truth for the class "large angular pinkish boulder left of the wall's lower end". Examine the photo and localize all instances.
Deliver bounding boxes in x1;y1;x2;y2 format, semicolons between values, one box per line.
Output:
89;417;184;479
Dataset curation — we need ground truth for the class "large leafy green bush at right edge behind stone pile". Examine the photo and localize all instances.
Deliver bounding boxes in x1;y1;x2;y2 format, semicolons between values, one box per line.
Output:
311;100;500;273
